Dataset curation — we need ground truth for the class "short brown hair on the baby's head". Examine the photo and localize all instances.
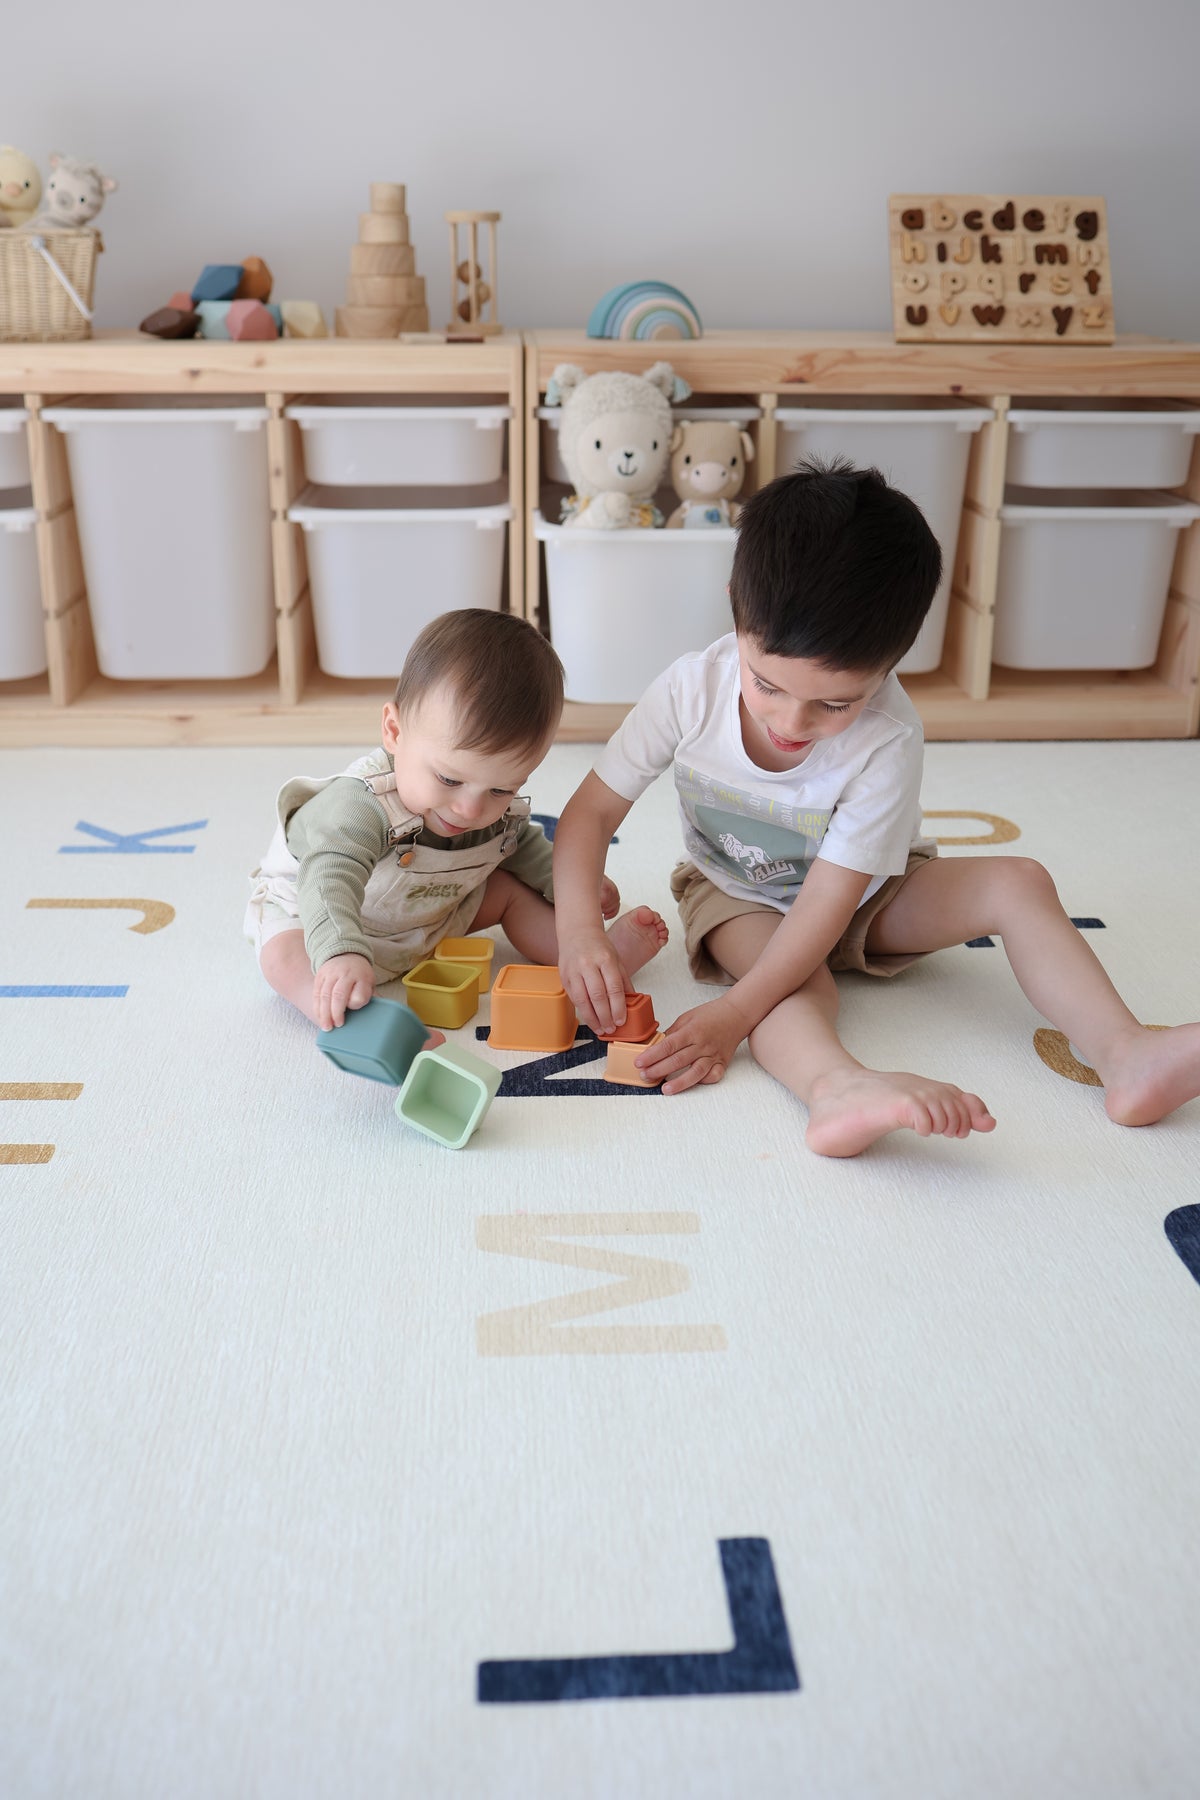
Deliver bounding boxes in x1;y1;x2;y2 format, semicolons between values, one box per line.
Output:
394;607;563;754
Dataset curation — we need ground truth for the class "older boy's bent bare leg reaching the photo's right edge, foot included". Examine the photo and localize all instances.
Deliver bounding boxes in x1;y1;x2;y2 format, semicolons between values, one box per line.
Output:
867;857;1200;1125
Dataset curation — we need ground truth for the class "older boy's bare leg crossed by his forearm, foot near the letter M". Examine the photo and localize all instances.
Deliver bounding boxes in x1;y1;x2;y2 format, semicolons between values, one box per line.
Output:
705;913;995;1156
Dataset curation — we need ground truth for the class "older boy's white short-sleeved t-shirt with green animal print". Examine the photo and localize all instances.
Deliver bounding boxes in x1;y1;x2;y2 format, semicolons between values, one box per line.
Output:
596;632;923;913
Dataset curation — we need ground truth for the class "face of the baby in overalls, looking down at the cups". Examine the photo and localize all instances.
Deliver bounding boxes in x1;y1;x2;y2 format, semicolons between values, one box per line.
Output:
381;686;549;837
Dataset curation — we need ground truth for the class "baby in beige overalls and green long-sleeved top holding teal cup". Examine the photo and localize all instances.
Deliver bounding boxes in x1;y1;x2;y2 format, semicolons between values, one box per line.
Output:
245;608;667;1030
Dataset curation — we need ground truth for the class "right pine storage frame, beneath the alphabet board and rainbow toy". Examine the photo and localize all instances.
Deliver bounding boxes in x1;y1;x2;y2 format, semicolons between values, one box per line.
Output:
525;331;1200;742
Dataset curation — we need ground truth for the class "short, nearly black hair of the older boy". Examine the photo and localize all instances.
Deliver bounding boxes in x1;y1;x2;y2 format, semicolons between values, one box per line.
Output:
729;457;941;671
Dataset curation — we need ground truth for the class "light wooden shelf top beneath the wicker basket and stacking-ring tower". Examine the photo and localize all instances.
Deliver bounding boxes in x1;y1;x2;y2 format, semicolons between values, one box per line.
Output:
0;331;522;394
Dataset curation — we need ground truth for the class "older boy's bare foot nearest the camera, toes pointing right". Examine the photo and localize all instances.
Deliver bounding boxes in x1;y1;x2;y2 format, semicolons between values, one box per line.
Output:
804;1069;995;1156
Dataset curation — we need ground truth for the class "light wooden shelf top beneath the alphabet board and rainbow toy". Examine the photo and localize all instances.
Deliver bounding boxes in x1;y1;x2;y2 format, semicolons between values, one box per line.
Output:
525;329;1200;400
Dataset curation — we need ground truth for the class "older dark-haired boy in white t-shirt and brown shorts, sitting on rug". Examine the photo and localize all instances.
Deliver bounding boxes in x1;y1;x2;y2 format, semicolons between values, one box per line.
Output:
554;450;1200;1156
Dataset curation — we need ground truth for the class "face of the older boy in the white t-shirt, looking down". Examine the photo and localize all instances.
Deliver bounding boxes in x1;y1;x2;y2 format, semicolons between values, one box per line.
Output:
738;637;889;769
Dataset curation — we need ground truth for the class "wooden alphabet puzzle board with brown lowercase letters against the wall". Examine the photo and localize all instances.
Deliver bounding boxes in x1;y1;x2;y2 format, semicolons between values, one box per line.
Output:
889;194;1115;344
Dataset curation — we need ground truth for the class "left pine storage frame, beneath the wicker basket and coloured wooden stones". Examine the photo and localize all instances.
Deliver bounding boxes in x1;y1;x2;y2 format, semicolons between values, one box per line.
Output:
0;331;525;745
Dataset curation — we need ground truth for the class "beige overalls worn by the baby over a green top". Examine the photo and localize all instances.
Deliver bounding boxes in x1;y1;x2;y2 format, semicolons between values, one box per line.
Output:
245;749;529;976
